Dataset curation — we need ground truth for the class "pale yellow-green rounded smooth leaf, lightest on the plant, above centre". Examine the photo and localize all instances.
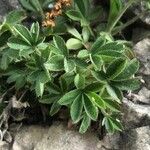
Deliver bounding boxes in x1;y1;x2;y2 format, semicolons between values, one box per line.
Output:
66;38;83;50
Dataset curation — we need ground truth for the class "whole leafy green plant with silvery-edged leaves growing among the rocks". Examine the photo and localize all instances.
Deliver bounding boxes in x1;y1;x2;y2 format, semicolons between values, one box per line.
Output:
0;0;139;133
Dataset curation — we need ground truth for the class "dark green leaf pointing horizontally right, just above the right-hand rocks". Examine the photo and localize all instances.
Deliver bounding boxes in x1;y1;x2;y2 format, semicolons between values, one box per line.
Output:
112;79;140;91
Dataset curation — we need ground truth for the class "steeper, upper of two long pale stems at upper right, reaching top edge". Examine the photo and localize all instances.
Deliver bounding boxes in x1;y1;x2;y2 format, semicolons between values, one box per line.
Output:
107;0;137;33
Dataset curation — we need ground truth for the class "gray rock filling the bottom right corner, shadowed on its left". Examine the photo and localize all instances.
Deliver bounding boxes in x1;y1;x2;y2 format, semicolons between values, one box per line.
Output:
120;126;150;150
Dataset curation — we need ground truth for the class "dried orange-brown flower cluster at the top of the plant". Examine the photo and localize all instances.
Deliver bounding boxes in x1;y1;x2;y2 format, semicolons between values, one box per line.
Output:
43;0;71;27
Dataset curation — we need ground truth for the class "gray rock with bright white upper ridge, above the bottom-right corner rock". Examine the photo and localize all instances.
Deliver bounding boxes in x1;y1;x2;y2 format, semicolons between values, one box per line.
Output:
122;99;150;129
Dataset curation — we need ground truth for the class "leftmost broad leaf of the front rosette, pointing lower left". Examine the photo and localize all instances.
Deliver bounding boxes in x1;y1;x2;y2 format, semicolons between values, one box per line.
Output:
58;89;81;105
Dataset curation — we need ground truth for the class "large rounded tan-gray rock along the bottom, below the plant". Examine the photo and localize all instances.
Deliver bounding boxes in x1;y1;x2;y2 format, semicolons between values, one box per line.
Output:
13;123;101;150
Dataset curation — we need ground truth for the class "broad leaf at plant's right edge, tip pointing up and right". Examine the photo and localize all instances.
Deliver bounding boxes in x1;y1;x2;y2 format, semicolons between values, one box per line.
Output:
114;58;139;80
